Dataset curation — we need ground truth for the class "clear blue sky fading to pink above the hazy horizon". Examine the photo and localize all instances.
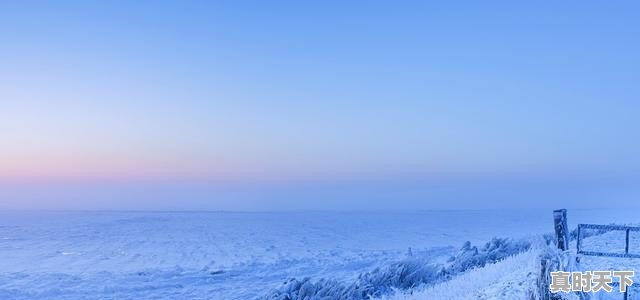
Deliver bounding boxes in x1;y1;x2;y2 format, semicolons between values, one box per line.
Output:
0;1;640;210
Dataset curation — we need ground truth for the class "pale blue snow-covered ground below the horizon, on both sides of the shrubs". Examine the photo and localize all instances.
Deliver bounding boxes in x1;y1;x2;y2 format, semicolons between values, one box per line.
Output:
0;210;637;299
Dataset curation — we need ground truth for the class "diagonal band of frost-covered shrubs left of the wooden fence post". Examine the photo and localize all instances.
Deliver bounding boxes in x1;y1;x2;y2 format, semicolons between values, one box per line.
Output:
263;238;531;300
